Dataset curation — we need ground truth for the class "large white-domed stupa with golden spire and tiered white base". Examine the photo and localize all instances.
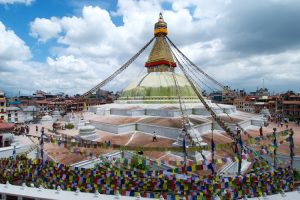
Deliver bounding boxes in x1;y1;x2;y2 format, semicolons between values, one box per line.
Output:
81;14;264;169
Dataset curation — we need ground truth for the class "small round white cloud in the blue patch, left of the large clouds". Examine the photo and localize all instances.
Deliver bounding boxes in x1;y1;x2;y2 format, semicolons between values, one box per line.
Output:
30;17;61;42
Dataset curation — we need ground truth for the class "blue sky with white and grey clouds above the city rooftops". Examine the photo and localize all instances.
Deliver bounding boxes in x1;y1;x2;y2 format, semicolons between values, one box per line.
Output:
0;0;300;94
